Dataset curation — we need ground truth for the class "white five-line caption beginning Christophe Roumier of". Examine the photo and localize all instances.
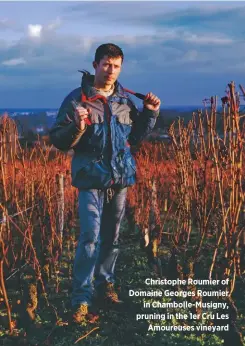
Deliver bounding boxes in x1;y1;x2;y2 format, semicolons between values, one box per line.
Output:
129;278;229;333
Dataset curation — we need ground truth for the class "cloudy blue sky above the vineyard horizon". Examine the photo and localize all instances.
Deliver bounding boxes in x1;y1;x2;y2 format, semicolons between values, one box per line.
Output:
0;1;245;108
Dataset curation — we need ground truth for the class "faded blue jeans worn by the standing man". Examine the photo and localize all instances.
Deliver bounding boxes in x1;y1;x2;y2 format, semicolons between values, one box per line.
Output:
72;187;127;306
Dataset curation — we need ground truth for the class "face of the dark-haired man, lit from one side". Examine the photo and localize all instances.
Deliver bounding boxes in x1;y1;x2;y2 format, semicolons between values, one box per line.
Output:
93;55;122;86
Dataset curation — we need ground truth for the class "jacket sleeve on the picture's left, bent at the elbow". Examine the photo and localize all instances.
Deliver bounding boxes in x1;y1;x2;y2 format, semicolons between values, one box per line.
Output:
49;94;87;151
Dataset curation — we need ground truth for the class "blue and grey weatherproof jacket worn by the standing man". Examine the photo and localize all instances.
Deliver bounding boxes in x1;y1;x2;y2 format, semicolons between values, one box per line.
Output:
49;74;159;189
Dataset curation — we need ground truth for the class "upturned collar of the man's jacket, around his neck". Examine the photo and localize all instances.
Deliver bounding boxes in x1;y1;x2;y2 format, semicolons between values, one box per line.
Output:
81;72;128;98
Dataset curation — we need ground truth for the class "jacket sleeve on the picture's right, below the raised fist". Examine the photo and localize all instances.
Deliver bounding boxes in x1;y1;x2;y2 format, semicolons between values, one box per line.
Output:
128;98;160;145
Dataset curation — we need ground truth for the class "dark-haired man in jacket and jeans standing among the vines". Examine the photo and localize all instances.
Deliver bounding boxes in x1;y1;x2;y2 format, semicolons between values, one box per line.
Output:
50;43;160;323
